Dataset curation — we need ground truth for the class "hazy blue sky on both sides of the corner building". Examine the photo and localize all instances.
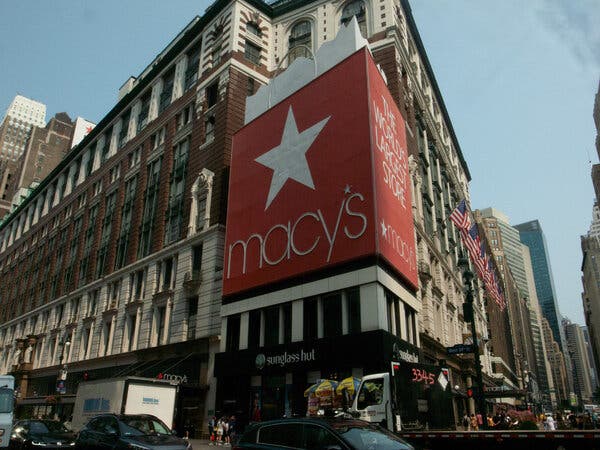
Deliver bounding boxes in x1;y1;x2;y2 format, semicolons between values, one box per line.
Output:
0;0;600;324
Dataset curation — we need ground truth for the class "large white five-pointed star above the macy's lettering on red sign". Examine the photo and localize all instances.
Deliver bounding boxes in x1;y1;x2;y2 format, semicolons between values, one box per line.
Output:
255;106;331;210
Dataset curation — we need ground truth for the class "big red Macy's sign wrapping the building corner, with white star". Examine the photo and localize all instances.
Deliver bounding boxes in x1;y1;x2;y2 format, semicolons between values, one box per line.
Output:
223;49;417;295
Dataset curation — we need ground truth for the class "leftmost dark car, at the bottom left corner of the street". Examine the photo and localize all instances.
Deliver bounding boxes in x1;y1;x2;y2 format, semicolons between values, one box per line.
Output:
9;420;75;449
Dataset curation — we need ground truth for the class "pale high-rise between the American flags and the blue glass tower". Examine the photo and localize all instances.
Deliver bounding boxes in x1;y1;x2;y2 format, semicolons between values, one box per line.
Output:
481;208;556;409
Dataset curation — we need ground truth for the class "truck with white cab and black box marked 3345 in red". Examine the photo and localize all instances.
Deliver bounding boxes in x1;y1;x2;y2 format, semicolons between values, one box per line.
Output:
350;361;454;432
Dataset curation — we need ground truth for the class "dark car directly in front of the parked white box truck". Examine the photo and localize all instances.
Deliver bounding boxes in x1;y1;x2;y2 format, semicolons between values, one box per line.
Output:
75;414;192;450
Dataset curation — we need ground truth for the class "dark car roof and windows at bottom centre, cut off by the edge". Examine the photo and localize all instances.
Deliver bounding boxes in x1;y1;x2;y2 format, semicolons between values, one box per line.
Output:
233;417;413;450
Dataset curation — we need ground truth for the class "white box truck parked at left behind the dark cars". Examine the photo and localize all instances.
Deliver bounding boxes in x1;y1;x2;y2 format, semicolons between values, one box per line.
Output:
71;377;178;431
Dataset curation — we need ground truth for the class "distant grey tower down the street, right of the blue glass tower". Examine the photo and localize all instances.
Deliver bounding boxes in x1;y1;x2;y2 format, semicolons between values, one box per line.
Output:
562;319;594;405
